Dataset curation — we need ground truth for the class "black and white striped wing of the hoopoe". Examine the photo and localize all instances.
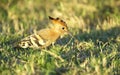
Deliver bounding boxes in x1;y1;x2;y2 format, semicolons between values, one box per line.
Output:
18;34;46;48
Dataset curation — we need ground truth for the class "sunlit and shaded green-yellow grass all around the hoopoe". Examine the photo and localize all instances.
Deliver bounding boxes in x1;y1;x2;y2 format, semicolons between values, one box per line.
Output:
0;0;120;75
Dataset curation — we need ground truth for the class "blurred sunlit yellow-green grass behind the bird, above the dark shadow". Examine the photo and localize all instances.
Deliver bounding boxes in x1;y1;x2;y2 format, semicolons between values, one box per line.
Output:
0;0;120;34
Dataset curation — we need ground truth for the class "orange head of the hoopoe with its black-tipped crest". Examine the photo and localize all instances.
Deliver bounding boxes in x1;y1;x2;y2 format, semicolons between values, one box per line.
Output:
49;16;68;34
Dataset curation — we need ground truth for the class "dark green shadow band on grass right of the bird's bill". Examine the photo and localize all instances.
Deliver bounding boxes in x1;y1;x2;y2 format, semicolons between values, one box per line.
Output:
57;26;120;46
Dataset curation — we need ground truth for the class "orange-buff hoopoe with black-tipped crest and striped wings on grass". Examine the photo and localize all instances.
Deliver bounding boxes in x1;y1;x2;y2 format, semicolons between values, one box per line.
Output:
13;16;68;48
